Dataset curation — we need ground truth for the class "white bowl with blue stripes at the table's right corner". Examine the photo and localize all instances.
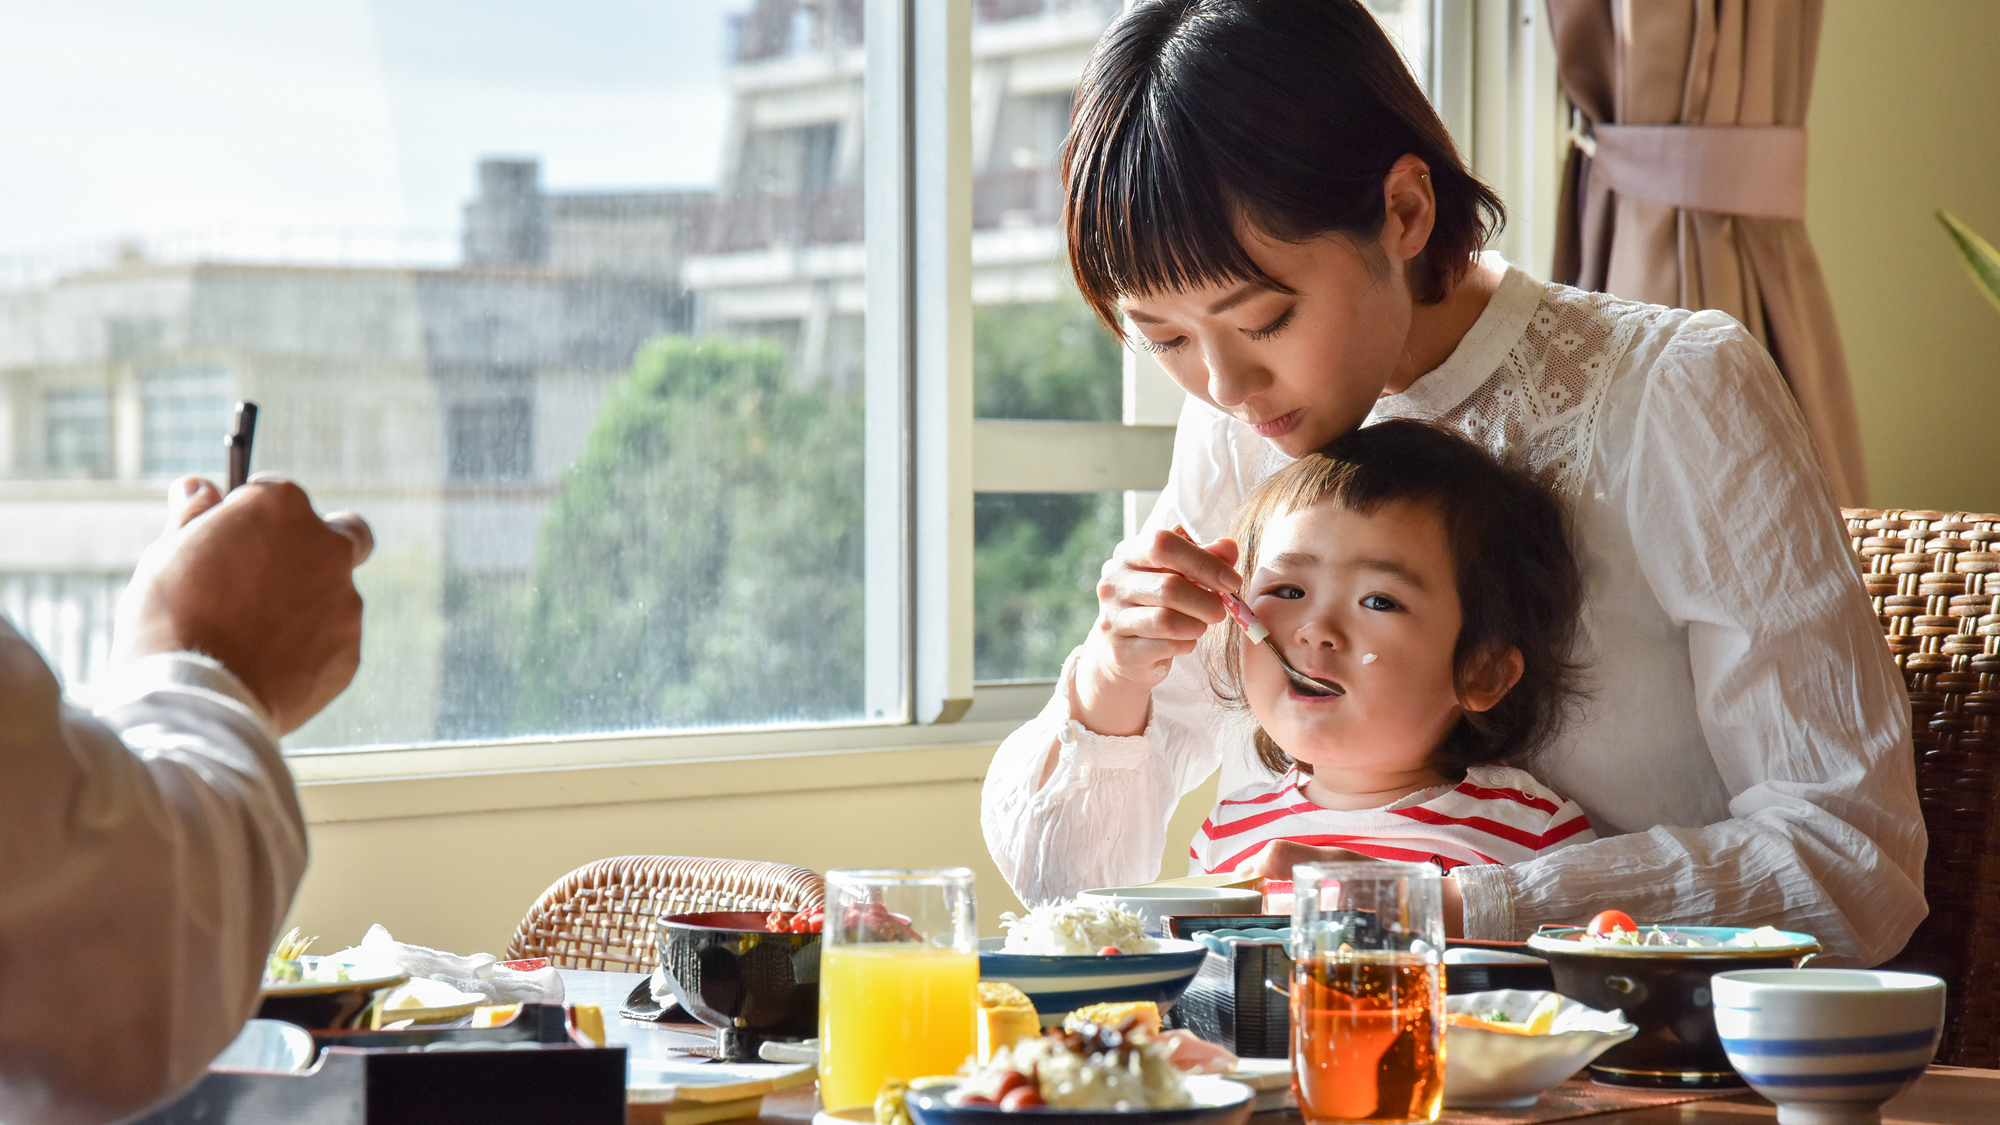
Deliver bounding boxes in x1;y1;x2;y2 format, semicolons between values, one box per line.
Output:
1712;969;1944;1125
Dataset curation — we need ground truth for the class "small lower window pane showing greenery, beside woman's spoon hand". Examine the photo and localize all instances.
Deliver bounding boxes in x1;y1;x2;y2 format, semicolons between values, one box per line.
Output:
972;492;1124;683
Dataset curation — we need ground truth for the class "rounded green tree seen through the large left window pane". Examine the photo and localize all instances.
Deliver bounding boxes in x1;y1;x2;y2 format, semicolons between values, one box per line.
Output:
514;336;862;731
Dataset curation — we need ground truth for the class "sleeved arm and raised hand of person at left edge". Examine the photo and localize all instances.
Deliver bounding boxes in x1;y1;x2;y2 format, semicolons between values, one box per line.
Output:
0;478;372;1123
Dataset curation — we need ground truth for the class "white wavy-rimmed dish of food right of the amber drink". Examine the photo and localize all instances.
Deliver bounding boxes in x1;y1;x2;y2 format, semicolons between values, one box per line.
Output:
1444;989;1638;1109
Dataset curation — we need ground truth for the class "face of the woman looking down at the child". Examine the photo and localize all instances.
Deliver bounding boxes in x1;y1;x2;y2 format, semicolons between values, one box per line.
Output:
1120;222;1412;456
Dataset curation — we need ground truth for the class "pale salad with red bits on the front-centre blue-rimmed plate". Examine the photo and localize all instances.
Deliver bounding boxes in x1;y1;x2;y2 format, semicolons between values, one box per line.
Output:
946;1017;1194;1111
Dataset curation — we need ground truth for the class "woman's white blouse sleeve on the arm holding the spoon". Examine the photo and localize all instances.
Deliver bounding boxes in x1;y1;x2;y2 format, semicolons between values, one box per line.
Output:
980;398;1242;907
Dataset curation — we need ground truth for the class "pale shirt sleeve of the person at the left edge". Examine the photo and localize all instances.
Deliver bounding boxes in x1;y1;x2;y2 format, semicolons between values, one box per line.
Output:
0;623;306;1121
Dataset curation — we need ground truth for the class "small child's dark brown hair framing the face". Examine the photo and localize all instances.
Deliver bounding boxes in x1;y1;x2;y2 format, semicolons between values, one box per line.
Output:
1202;418;1584;781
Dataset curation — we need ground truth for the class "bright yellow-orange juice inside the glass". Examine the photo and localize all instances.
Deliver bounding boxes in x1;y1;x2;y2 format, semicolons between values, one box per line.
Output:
820;943;980;1109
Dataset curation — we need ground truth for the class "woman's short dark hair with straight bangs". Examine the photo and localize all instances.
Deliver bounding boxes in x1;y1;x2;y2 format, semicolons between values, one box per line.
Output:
1062;0;1506;326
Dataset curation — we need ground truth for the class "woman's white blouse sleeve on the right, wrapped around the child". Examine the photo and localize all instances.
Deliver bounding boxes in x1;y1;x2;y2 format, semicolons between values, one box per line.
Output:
1462;312;1926;965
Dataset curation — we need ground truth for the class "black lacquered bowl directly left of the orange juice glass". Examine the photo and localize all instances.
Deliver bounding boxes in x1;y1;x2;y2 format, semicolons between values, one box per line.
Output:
660;911;820;1061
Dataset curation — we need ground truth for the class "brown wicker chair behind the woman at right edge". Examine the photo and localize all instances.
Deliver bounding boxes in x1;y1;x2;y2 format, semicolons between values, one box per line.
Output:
1844;508;2000;1067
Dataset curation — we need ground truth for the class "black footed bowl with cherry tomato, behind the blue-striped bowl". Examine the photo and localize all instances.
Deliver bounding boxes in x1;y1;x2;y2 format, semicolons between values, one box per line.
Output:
1528;925;1820;1089
